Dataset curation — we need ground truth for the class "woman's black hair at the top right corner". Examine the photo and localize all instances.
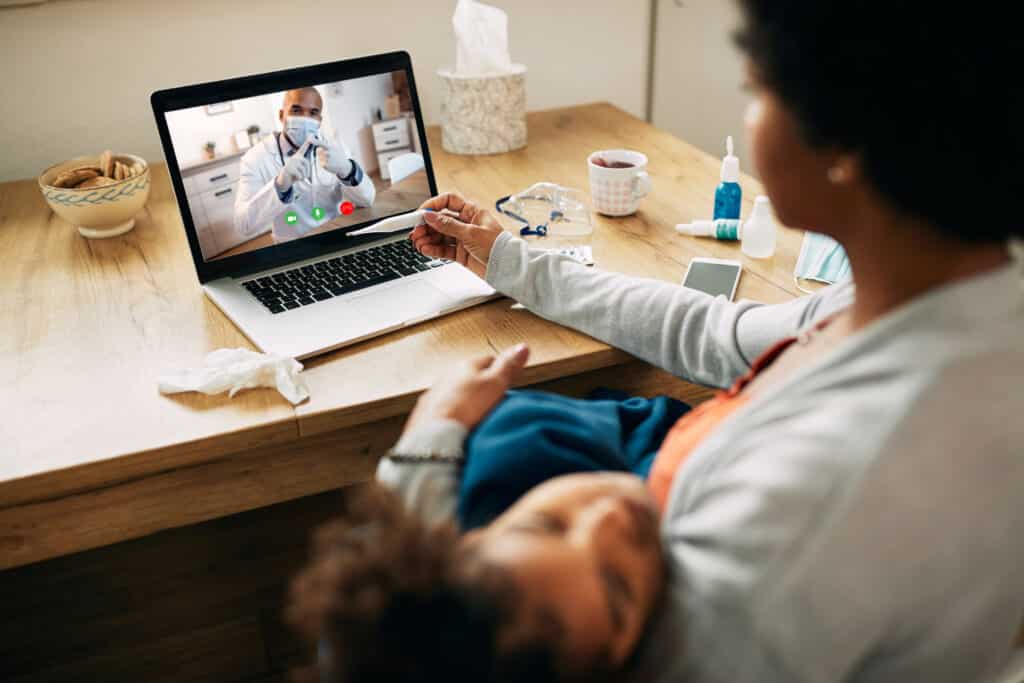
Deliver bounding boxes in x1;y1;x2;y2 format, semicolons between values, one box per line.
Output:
737;0;1024;243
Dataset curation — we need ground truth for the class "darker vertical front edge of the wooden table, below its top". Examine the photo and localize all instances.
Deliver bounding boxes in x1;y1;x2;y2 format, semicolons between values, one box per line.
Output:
0;360;713;570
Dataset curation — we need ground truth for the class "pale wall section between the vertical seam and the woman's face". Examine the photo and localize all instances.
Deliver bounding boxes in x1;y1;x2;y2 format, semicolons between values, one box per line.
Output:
651;0;754;174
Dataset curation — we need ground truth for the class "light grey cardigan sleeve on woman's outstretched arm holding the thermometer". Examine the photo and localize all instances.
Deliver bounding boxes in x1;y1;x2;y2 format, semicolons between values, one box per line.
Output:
486;232;852;387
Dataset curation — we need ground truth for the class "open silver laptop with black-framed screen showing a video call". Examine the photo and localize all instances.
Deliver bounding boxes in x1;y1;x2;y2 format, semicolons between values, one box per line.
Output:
151;52;496;358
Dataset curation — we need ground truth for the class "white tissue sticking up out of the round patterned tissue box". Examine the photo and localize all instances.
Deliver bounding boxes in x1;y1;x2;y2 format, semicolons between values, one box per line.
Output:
452;0;513;77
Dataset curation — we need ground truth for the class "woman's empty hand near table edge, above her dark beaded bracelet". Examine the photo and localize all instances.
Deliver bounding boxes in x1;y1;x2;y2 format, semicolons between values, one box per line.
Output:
403;344;529;432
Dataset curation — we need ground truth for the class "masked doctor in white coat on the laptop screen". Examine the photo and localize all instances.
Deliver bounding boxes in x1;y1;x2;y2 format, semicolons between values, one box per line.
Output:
234;88;377;242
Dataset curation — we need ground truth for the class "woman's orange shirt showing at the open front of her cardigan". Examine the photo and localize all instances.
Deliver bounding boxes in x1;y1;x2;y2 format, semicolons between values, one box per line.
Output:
647;333;802;511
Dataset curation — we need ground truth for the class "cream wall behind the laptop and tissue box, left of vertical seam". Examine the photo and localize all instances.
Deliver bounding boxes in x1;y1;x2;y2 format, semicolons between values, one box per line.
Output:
0;0;647;181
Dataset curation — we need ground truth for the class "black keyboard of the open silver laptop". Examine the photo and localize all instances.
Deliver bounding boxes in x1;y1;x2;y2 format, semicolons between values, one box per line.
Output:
242;240;449;313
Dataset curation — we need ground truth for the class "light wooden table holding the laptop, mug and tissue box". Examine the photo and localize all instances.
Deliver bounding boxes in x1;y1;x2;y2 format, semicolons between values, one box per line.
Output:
0;103;801;568
